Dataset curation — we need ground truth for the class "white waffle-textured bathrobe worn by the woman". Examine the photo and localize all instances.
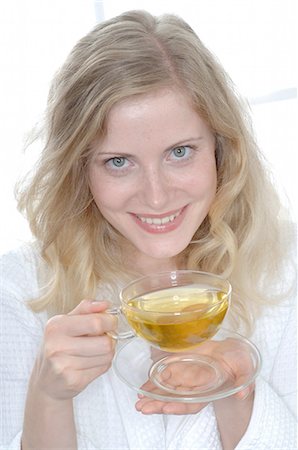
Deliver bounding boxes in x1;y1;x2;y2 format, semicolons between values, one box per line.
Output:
0;245;297;450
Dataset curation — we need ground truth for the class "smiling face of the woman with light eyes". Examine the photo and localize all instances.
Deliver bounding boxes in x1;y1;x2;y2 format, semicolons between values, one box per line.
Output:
89;90;217;268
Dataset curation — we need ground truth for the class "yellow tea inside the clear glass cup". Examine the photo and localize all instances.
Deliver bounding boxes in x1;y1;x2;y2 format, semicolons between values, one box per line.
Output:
124;285;228;352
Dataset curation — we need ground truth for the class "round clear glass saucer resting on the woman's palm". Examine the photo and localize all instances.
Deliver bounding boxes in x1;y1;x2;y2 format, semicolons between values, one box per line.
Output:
113;329;261;403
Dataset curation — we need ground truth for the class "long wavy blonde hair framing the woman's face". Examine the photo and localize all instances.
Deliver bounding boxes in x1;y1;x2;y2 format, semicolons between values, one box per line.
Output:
19;11;294;329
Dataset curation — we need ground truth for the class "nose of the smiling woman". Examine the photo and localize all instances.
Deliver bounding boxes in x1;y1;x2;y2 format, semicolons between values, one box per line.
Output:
139;167;173;212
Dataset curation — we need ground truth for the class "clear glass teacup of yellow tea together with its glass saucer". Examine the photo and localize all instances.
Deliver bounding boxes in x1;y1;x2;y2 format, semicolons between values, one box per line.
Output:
109;270;261;402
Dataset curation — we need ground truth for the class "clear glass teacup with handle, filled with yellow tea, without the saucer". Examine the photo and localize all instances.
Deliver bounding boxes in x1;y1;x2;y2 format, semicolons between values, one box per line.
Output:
110;270;232;352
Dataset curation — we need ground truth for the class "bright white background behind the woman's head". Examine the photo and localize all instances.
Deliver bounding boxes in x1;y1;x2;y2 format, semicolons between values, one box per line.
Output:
0;0;298;252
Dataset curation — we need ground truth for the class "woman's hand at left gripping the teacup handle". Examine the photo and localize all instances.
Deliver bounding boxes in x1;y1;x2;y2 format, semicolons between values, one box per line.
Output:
31;300;117;400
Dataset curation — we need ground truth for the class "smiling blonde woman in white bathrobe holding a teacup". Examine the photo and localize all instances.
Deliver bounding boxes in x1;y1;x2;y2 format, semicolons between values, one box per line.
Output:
1;11;296;450
